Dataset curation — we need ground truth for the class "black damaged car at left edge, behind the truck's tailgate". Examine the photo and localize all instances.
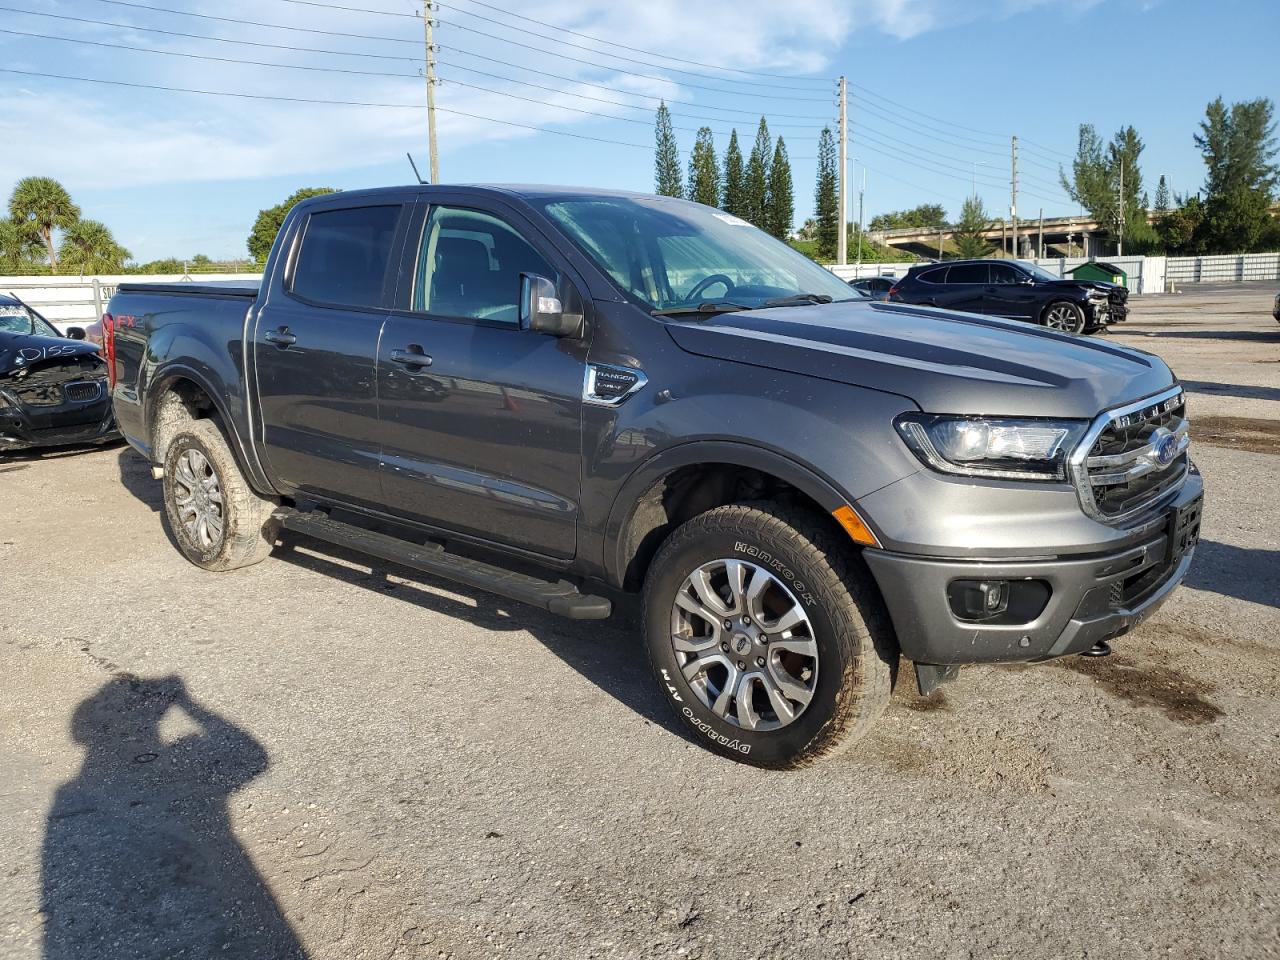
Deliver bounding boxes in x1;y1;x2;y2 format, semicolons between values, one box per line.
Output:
0;294;118;454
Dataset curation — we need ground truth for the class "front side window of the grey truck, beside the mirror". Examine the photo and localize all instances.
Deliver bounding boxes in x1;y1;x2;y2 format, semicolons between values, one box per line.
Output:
413;206;559;324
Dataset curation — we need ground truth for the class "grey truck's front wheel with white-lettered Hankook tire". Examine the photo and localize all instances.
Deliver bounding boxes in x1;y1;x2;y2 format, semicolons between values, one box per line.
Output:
644;503;897;768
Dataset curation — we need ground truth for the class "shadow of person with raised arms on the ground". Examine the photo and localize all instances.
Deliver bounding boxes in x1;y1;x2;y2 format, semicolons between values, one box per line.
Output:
42;675;306;960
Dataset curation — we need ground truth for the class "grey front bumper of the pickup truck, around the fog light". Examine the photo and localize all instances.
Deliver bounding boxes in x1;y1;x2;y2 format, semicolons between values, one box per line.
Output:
863;474;1203;664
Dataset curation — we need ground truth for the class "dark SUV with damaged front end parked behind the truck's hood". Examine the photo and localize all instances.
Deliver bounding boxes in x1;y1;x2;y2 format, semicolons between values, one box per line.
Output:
890;260;1129;333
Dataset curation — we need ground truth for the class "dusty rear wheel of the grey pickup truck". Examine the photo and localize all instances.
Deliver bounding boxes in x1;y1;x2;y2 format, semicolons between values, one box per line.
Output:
164;420;279;571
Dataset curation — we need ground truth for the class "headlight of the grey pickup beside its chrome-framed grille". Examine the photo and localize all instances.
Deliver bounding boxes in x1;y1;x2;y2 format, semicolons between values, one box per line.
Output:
893;413;1088;480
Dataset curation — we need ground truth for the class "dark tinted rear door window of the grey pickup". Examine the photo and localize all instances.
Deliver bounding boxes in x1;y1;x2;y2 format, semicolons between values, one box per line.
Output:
292;204;401;307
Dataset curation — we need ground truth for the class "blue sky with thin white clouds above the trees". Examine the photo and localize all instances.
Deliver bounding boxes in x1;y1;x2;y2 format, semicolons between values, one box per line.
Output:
0;0;1280;261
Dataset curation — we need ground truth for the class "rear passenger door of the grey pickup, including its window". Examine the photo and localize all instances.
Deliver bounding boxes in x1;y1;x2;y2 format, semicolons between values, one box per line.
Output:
253;195;412;507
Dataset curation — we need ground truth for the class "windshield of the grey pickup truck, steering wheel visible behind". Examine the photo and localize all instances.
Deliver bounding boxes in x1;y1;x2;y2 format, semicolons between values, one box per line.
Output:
543;197;860;310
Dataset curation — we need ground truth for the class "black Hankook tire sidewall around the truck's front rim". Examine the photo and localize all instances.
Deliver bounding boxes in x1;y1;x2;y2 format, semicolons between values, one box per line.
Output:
644;522;852;767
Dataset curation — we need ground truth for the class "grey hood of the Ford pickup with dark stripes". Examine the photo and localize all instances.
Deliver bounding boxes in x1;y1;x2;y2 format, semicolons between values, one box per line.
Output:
667;301;1175;419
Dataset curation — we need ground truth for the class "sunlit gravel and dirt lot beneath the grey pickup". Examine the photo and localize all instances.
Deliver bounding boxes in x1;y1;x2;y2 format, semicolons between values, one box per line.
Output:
0;284;1280;960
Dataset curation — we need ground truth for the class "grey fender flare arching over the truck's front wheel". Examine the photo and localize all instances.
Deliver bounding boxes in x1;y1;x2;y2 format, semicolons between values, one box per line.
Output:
604;440;851;586
